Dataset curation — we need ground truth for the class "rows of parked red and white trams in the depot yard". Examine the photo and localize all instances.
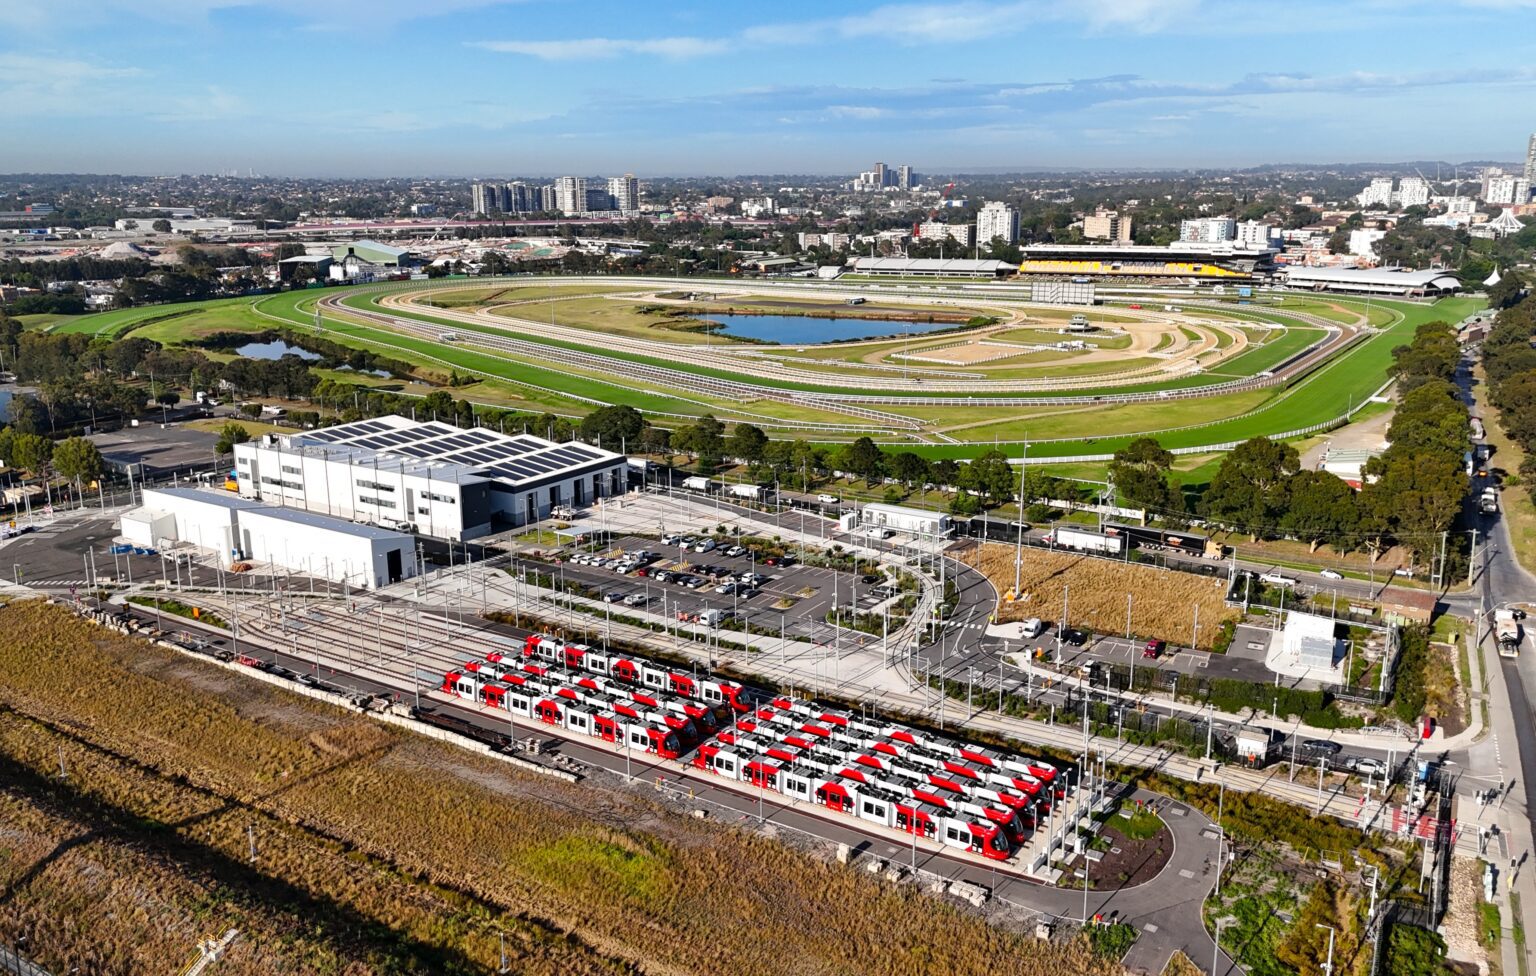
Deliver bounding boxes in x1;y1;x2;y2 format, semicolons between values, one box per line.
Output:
442;635;1068;861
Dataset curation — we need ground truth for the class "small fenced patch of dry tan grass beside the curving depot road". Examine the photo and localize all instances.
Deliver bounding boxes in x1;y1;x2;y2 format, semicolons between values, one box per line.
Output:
962;543;1238;649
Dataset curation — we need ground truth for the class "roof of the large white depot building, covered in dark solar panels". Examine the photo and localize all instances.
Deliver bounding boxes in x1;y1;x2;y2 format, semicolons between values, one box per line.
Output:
289;417;625;484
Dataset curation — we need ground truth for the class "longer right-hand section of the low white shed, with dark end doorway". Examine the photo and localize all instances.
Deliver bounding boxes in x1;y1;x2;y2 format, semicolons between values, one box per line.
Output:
240;507;419;590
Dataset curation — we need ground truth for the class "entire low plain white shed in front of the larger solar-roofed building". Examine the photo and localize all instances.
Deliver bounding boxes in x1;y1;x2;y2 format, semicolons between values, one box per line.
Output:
120;487;418;589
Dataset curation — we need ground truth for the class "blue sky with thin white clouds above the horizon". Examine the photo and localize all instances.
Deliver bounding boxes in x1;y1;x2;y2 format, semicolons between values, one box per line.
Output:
0;0;1536;177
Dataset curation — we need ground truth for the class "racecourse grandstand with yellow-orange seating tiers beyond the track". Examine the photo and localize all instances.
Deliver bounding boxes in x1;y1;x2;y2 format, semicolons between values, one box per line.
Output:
1018;243;1275;281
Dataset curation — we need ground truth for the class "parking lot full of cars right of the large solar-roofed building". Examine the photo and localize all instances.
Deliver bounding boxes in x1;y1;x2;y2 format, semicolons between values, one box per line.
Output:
522;535;891;641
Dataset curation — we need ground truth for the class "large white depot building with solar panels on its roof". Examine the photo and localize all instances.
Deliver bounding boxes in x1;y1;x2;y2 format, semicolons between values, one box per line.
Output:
235;417;628;539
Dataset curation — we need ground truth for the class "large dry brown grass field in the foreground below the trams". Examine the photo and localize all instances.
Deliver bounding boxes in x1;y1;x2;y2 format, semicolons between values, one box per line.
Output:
0;604;1118;976
